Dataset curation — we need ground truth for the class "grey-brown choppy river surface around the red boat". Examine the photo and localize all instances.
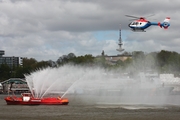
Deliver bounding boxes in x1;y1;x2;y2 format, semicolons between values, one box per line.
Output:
0;95;180;120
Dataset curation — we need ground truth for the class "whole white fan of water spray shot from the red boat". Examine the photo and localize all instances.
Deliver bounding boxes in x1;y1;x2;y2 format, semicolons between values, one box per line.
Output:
26;65;179;104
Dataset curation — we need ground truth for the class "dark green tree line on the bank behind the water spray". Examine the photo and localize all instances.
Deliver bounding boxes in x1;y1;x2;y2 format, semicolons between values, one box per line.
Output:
0;50;180;81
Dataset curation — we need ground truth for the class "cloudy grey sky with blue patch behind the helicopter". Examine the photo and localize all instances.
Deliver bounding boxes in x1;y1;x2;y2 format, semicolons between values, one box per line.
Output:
0;0;180;61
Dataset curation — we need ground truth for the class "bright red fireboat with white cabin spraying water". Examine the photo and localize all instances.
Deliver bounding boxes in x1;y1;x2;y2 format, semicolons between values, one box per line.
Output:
4;93;69;105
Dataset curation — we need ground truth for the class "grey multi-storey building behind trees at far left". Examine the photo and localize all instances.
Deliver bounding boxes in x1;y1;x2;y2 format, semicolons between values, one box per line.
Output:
0;50;22;69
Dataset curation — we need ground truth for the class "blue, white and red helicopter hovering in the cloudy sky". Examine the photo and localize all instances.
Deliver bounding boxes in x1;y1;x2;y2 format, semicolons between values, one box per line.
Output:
125;15;170;32
